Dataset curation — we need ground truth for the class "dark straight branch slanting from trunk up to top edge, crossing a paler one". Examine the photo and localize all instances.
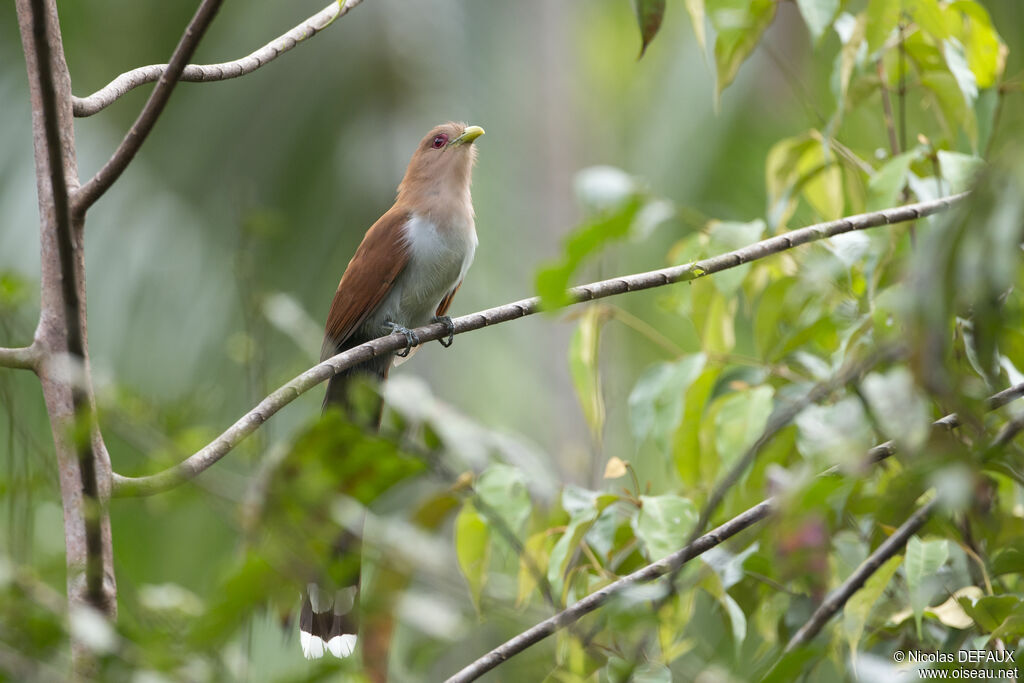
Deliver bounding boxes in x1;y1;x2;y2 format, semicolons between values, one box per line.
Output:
72;0;223;216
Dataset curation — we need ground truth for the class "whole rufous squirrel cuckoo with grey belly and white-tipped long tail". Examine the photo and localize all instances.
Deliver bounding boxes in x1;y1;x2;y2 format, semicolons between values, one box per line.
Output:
299;123;483;658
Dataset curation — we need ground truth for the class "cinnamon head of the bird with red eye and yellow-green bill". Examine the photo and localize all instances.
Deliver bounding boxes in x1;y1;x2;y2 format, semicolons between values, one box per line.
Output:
398;122;483;203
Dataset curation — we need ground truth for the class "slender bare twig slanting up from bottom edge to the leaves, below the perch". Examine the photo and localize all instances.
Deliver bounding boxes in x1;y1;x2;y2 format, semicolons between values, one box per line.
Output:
446;499;774;683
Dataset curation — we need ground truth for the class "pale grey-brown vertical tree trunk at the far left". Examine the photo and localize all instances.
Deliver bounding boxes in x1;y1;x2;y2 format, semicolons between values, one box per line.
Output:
16;0;117;626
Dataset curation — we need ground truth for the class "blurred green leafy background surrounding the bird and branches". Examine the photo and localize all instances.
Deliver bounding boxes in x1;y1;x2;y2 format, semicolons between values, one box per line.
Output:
0;0;1024;681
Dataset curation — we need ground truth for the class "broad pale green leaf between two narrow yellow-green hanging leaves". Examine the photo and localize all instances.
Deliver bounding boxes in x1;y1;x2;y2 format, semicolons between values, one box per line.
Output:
629;353;706;444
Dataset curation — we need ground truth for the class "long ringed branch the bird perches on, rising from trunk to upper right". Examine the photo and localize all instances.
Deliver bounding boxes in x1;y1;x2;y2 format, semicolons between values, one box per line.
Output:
114;193;968;496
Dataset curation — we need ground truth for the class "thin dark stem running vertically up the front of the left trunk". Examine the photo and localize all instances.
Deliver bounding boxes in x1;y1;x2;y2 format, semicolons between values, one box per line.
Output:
30;0;111;613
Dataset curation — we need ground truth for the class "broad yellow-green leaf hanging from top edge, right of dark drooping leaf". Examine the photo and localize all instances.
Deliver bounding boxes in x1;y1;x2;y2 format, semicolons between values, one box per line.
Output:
708;0;777;99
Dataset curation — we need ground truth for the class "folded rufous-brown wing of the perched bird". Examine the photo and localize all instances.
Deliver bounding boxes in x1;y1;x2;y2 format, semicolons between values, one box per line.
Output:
321;209;410;360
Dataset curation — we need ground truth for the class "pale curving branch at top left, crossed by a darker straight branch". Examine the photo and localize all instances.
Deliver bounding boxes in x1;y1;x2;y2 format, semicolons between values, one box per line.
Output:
72;0;362;117
